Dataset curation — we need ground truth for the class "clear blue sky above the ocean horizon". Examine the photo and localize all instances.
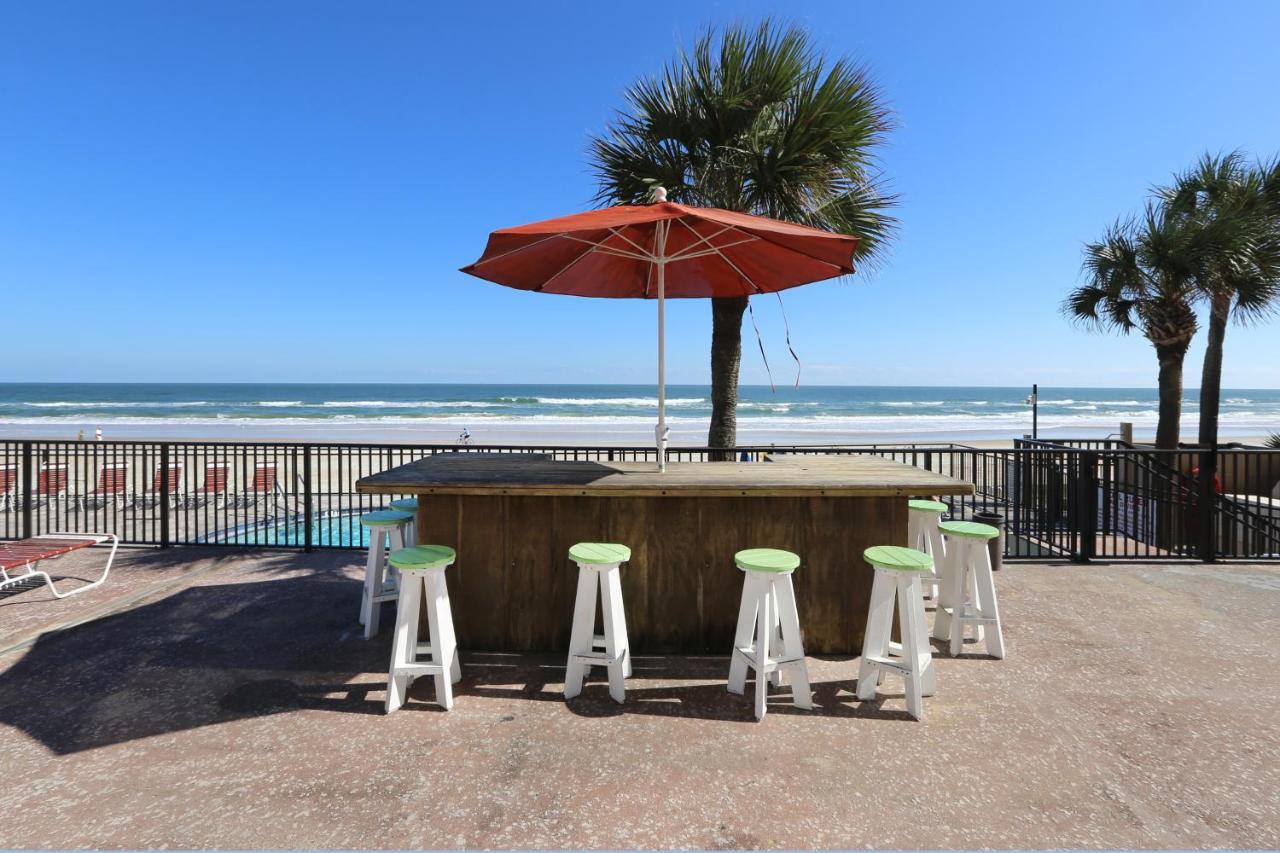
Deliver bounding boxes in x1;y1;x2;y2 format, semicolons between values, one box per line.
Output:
0;0;1280;388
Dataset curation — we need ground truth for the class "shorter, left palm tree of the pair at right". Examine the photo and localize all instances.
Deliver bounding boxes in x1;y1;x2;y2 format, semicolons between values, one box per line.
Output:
1062;204;1197;448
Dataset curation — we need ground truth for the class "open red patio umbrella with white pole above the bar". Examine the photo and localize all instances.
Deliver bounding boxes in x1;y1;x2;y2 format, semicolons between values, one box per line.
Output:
462;187;858;470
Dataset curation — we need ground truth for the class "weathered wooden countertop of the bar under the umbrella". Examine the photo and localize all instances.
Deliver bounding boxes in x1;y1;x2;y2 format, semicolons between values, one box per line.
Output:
356;452;973;497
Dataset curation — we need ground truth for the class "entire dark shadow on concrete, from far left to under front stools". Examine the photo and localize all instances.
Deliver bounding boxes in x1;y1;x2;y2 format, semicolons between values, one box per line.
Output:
0;551;931;754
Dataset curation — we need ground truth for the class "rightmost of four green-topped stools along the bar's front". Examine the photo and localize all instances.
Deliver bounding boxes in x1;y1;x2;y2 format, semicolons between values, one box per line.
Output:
858;546;937;720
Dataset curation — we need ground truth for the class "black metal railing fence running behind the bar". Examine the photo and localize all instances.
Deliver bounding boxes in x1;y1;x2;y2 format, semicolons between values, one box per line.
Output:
0;441;1280;561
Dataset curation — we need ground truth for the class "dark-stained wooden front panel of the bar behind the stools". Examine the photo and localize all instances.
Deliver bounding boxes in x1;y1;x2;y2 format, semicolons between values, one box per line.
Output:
419;494;906;654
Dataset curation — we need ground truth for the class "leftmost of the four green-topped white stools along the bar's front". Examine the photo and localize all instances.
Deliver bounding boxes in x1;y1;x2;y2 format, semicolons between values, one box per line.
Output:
387;544;462;713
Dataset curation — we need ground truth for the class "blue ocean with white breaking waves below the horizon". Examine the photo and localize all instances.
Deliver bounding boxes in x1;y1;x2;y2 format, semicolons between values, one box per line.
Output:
0;383;1280;446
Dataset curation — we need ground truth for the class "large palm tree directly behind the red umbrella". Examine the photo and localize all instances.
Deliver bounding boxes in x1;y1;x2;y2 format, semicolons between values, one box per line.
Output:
590;20;896;448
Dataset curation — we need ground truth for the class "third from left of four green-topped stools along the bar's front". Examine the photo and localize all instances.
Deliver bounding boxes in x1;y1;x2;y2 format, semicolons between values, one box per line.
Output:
728;548;813;720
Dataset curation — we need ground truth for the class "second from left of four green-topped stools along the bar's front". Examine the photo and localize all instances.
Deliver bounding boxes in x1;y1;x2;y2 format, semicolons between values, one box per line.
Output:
564;542;631;702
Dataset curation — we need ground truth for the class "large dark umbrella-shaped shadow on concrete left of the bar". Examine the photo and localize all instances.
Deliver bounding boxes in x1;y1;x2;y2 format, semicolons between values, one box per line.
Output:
0;555;390;753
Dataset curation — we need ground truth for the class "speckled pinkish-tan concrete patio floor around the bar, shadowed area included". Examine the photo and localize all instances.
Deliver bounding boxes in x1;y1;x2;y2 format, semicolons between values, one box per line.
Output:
0;548;1280;848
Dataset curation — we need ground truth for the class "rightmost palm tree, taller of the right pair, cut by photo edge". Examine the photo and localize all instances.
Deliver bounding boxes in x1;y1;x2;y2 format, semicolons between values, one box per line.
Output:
1157;152;1280;447
